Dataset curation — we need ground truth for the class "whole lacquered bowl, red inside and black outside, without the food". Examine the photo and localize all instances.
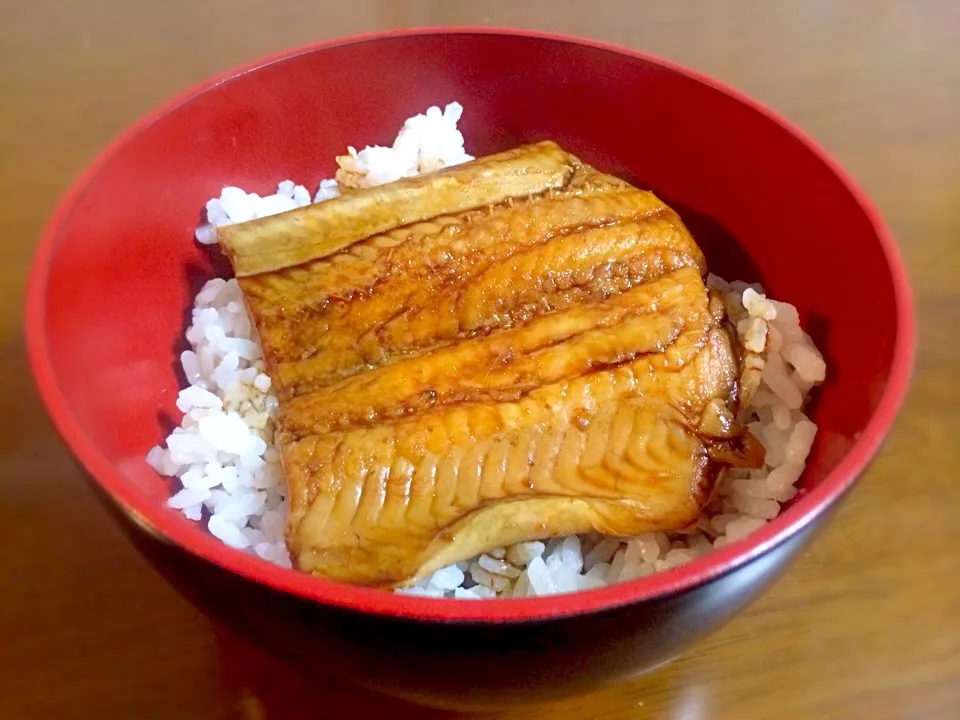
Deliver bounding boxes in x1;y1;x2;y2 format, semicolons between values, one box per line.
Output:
26;28;914;707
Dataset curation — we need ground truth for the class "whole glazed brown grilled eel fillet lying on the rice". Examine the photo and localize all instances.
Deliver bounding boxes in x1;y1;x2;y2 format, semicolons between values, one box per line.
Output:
221;143;763;587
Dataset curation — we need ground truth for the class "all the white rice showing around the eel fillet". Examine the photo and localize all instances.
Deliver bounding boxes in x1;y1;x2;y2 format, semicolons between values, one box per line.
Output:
147;103;826;599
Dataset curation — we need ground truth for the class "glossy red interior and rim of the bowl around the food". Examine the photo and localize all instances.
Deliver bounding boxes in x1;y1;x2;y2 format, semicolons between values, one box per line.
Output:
27;31;913;620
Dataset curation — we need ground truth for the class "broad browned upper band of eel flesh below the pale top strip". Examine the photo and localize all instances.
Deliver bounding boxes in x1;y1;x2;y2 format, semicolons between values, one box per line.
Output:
240;177;703;396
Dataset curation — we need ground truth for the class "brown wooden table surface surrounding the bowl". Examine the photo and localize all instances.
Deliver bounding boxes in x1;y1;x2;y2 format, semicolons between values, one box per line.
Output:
0;0;960;720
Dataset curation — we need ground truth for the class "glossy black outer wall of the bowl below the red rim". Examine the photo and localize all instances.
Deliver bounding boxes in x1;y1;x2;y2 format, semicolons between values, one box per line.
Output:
100;472;831;710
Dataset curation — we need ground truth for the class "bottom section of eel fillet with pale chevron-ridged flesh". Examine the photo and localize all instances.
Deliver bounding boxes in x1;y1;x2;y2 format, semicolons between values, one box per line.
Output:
283;331;735;584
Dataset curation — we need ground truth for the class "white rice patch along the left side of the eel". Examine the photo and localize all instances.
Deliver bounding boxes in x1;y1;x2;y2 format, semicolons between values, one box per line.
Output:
147;278;290;567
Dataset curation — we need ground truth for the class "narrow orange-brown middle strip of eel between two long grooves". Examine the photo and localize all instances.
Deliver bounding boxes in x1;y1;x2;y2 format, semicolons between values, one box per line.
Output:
282;268;709;437
